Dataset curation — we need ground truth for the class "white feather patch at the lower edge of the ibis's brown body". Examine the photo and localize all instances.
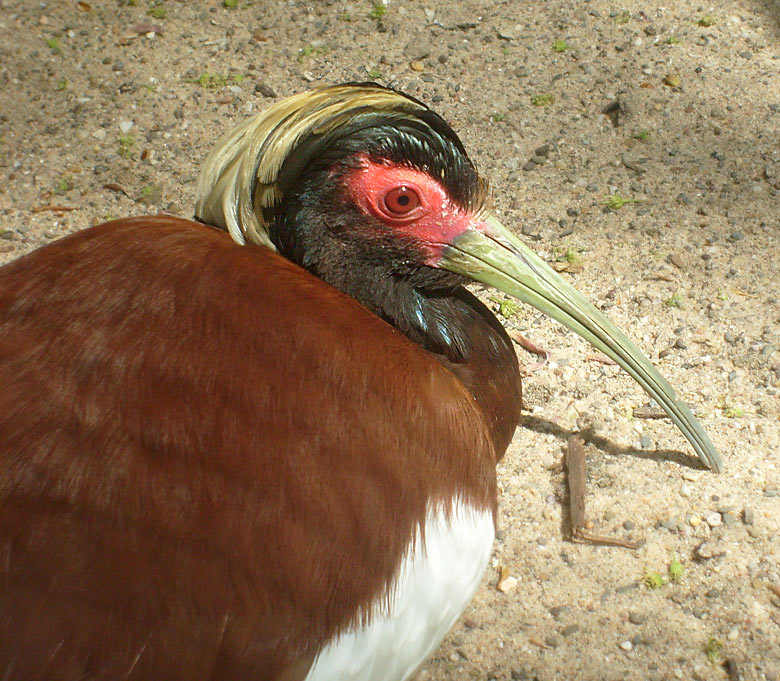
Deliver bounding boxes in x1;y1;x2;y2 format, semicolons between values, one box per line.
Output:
306;502;494;681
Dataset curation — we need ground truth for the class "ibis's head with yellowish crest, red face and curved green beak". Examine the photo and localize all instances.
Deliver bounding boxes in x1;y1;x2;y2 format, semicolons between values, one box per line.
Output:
196;83;722;470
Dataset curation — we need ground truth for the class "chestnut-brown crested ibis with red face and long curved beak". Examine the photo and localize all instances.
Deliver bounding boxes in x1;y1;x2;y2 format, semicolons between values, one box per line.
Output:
0;83;722;681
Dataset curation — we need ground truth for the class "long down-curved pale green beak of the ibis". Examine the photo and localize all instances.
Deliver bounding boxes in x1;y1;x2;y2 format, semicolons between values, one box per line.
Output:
438;216;723;472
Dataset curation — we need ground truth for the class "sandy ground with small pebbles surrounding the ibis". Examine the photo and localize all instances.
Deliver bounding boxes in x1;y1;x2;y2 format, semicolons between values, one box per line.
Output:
0;0;780;681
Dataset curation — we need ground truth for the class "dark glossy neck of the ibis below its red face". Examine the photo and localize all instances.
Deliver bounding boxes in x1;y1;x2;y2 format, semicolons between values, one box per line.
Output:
269;159;522;457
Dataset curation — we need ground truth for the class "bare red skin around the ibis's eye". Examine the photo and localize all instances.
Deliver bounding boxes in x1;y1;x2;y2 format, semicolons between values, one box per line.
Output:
345;158;479;267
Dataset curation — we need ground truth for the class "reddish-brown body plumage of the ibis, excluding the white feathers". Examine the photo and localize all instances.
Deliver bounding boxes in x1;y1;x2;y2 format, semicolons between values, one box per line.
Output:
0;217;500;681
